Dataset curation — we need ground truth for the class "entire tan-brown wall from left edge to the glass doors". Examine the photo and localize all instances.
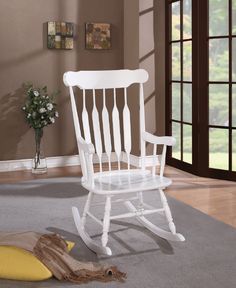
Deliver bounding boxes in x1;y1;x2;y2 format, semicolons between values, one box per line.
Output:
0;0;165;160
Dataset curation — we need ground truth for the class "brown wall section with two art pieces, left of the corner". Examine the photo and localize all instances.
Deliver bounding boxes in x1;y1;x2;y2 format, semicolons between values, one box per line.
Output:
0;0;123;160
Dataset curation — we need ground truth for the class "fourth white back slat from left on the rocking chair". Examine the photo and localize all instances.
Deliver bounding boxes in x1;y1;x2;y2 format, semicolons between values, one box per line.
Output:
112;88;121;169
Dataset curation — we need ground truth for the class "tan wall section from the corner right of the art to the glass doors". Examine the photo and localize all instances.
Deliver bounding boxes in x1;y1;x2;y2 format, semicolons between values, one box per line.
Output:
124;0;165;154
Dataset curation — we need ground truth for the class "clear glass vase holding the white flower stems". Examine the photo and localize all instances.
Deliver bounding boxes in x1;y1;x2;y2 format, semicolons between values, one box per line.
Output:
32;129;47;174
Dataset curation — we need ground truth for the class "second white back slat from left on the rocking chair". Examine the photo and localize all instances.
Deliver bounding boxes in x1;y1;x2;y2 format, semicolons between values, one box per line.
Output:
92;89;102;171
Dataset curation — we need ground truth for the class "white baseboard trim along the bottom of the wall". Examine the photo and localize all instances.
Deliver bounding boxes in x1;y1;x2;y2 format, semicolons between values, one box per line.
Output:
0;152;159;172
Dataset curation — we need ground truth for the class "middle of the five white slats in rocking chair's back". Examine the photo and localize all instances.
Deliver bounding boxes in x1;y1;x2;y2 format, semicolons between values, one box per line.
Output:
102;89;112;170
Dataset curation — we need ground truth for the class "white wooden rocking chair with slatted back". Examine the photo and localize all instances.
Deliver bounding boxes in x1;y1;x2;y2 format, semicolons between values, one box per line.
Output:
63;69;185;255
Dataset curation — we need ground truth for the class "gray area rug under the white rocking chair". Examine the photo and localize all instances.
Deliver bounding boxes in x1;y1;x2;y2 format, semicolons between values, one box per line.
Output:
0;178;236;288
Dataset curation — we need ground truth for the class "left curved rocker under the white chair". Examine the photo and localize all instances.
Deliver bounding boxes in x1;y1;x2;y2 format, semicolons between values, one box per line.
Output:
72;207;112;256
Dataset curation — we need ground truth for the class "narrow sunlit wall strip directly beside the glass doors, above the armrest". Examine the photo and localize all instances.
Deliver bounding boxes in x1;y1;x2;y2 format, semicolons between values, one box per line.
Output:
139;0;166;140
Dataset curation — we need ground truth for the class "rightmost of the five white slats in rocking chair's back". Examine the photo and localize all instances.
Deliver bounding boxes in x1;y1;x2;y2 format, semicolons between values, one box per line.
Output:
123;88;131;169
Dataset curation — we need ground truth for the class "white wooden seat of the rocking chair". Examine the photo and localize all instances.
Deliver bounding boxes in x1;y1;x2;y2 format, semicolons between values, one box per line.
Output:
83;169;172;194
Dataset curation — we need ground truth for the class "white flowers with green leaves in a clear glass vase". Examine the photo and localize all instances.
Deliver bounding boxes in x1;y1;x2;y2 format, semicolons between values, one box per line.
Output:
22;84;59;174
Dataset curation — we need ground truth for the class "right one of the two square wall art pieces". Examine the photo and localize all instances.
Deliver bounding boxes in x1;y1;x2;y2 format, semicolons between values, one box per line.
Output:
85;23;111;50
